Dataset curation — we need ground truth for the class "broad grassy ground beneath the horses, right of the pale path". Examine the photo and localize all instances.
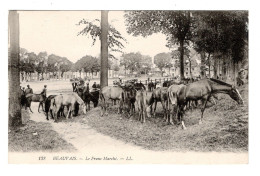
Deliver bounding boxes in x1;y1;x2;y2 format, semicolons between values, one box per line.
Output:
83;85;248;152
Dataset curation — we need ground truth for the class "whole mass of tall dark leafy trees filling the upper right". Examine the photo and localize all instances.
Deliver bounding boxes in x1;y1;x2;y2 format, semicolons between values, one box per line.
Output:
124;11;248;79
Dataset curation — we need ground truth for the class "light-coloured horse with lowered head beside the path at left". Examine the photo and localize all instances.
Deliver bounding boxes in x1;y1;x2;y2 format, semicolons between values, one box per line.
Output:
50;93;87;122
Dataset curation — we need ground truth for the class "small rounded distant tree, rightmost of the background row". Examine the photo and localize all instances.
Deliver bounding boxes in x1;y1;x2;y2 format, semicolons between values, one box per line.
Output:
154;53;172;76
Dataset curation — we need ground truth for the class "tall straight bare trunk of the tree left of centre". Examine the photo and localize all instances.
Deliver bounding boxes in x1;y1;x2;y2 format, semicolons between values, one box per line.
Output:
100;10;108;88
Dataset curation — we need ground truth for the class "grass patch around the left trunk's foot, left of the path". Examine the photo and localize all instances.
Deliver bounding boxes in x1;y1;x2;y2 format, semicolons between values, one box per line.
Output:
8;110;76;152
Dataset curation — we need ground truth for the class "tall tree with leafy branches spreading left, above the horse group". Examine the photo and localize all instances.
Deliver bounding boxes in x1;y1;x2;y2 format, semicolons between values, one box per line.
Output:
125;11;192;79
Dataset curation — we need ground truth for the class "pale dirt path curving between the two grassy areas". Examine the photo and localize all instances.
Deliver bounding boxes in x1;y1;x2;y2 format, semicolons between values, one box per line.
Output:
30;103;141;152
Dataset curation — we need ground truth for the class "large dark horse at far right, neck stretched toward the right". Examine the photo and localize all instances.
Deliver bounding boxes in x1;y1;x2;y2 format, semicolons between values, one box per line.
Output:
177;79;244;129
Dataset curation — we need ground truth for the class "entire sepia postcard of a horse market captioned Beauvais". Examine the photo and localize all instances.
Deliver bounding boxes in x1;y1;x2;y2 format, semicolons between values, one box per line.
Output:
8;9;249;164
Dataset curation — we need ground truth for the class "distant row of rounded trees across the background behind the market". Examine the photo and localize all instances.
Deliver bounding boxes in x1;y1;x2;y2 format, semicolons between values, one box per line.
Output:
20;48;185;79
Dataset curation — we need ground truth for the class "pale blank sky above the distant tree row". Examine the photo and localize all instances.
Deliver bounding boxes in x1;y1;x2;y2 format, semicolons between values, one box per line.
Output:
19;11;170;62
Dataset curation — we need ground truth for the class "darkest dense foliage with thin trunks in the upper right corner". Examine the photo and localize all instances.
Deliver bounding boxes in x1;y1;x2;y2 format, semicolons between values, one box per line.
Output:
193;11;248;81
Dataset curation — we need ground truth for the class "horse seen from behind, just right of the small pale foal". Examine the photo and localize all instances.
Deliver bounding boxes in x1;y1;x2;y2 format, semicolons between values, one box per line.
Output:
153;87;168;120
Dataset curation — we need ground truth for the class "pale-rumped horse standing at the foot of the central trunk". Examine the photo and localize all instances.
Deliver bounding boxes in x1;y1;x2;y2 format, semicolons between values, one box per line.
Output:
99;86;124;117
